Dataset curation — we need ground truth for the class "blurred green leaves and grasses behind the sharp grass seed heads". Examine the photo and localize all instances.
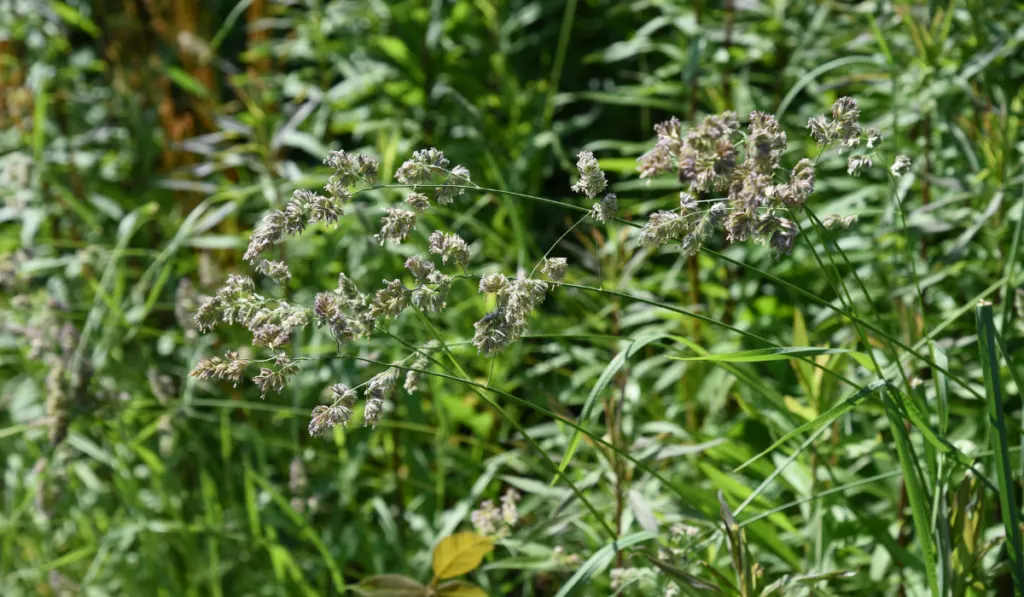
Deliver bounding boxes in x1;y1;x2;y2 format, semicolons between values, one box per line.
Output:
0;0;1024;596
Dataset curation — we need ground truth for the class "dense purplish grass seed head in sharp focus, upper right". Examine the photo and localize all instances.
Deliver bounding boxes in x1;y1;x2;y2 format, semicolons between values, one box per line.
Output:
630;97;882;257
